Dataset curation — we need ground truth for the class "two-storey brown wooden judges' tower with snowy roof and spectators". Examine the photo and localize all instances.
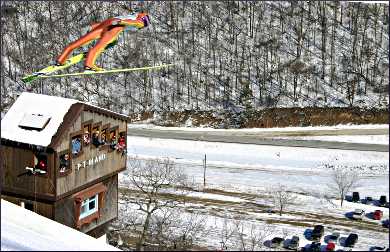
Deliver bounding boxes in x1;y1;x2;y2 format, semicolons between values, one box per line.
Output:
1;93;128;237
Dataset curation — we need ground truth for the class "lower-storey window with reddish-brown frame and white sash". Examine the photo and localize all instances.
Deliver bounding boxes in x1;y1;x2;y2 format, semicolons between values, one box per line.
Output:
74;183;107;228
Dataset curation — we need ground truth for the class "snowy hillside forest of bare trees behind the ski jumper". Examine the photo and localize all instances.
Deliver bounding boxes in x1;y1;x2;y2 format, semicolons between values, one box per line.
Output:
1;1;389;114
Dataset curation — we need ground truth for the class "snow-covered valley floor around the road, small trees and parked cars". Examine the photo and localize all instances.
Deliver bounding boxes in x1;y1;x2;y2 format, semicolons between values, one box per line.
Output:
119;125;389;250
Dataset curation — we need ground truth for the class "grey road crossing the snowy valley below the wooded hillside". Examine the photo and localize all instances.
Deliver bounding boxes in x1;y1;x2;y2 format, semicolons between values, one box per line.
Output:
127;127;389;152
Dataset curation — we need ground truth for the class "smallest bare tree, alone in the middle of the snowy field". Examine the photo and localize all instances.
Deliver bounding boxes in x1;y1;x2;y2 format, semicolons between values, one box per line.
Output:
269;184;297;216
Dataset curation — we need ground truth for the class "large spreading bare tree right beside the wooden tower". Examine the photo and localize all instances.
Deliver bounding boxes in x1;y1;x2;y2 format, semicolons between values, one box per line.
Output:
129;158;187;250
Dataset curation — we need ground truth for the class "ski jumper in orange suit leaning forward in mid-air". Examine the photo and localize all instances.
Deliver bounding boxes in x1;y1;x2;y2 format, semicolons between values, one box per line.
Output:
56;12;150;71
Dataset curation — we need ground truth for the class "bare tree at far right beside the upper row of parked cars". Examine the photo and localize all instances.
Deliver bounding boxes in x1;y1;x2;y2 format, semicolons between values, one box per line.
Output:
325;164;359;207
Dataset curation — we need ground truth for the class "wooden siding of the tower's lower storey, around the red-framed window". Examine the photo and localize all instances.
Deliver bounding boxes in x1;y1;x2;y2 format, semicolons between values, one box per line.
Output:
55;175;118;233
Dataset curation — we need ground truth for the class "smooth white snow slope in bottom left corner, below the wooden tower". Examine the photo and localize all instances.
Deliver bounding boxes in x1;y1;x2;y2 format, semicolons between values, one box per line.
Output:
1;199;120;251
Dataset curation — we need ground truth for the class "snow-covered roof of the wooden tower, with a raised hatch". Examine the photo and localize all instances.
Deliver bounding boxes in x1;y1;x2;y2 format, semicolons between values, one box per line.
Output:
1;92;126;147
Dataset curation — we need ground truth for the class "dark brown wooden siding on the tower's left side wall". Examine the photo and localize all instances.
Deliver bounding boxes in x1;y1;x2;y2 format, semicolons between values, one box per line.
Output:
1;145;55;198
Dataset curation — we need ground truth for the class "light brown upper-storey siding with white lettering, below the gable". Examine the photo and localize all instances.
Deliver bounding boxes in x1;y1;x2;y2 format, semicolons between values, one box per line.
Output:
55;111;127;196
